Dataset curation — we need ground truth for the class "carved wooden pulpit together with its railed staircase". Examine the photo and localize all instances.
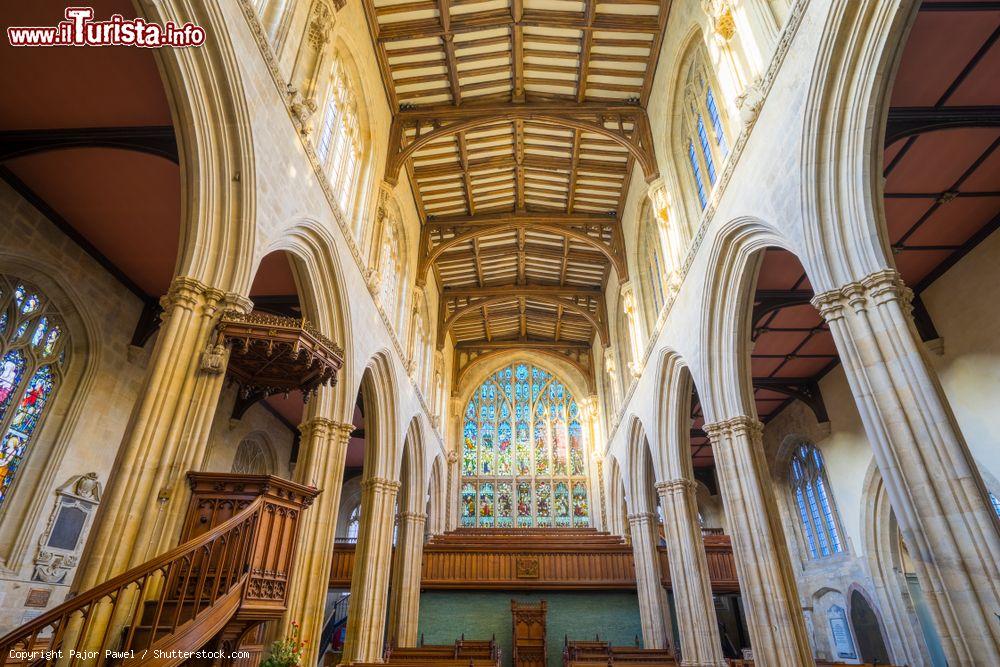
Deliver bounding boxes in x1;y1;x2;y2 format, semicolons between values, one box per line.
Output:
0;473;319;667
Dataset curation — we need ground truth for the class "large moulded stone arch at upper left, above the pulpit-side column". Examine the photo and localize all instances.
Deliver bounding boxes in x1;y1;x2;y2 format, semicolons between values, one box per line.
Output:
143;0;257;294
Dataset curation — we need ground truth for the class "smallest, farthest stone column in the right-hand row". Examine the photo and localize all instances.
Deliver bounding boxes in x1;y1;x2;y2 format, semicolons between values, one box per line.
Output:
628;512;671;648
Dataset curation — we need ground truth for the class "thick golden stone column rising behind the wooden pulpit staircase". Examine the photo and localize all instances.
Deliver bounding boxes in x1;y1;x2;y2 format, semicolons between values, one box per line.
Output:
74;276;252;591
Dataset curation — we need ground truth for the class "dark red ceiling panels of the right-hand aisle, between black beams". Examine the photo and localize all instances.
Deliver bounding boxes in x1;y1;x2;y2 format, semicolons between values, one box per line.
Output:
691;1;1000;467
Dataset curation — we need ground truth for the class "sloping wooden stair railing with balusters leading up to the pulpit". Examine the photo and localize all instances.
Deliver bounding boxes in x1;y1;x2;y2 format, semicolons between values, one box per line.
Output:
0;496;265;666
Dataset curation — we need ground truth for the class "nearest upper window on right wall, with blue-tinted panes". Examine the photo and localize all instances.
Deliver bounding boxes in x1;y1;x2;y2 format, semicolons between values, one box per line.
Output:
682;52;729;208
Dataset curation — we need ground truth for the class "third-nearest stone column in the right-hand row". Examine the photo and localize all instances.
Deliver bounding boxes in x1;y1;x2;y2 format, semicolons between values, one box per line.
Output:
656;479;728;667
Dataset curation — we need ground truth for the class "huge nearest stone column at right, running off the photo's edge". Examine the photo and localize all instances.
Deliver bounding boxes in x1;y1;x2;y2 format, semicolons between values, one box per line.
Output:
813;270;1000;665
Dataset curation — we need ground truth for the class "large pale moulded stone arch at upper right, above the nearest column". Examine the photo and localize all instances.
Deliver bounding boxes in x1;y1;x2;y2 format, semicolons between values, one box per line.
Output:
802;0;920;293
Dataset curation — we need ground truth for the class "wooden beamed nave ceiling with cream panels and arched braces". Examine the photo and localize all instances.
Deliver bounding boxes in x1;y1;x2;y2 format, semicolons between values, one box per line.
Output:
364;0;670;366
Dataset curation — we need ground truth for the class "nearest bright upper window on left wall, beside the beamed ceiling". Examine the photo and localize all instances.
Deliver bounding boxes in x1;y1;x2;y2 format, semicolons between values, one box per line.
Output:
316;61;363;213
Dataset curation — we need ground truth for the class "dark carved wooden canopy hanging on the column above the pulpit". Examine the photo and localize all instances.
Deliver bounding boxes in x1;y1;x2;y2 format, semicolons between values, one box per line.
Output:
218;312;344;418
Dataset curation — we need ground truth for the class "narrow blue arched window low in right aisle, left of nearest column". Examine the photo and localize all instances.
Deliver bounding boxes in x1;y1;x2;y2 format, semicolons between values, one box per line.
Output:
788;443;844;558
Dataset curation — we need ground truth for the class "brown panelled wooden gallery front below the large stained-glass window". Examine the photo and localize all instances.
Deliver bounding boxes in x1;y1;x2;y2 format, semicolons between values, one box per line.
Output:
330;529;739;593
